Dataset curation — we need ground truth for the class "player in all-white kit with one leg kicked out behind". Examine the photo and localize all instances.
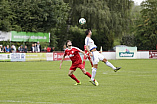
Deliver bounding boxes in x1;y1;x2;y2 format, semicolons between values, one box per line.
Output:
85;29;121;85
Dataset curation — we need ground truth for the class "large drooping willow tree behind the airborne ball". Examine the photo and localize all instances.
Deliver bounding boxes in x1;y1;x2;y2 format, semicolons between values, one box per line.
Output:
64;0;133;50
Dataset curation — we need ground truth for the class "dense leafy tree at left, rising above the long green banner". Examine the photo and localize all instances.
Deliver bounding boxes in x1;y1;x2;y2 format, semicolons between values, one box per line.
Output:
0;0;70;46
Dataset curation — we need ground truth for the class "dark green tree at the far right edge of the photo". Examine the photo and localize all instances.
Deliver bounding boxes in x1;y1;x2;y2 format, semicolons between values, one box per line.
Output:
135;0;157;50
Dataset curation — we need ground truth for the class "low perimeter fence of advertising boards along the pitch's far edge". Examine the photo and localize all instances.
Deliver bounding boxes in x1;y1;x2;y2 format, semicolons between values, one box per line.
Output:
0;50;157;62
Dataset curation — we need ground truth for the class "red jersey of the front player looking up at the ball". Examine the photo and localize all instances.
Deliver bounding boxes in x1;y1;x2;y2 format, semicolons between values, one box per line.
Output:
64;47;82;65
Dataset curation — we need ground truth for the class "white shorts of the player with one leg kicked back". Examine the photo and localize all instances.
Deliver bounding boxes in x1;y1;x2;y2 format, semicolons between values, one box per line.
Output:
92;51;104;65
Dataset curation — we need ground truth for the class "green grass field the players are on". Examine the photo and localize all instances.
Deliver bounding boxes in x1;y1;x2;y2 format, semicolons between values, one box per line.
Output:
0;60;157;104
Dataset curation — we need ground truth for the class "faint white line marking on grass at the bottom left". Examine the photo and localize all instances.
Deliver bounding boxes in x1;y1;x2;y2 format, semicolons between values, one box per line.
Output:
0;100;71;104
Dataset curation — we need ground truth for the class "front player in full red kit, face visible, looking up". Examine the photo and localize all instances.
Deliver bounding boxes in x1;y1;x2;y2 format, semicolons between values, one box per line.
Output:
60;40;98;85
